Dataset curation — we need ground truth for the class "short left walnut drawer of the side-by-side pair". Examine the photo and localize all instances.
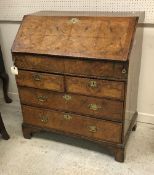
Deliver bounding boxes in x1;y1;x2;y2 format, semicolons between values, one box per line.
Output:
16;70;64;92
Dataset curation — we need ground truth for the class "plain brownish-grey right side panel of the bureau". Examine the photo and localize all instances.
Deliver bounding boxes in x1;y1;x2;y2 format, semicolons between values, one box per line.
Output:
123;27;143;139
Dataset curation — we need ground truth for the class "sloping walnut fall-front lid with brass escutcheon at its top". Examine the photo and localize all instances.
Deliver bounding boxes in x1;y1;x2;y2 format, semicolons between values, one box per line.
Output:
12;15;138;61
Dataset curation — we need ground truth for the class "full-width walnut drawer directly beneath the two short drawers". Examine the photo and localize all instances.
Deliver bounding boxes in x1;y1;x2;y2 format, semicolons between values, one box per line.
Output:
18;87;123;121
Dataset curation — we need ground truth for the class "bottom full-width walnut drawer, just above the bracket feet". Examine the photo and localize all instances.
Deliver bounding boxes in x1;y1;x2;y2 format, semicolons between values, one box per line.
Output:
22;105;122;143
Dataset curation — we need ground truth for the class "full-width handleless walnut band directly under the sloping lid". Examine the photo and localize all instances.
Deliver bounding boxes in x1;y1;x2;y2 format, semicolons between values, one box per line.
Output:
13;54;127;79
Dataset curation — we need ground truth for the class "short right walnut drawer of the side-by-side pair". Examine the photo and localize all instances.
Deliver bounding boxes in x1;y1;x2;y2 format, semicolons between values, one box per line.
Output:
66;76;124;100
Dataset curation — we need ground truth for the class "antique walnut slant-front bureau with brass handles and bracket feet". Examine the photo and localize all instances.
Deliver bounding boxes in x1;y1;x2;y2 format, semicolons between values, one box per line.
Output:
12;12;143;162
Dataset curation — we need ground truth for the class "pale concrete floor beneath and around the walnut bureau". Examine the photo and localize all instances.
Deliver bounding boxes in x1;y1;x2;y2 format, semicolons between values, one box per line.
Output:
0;100;154;175
